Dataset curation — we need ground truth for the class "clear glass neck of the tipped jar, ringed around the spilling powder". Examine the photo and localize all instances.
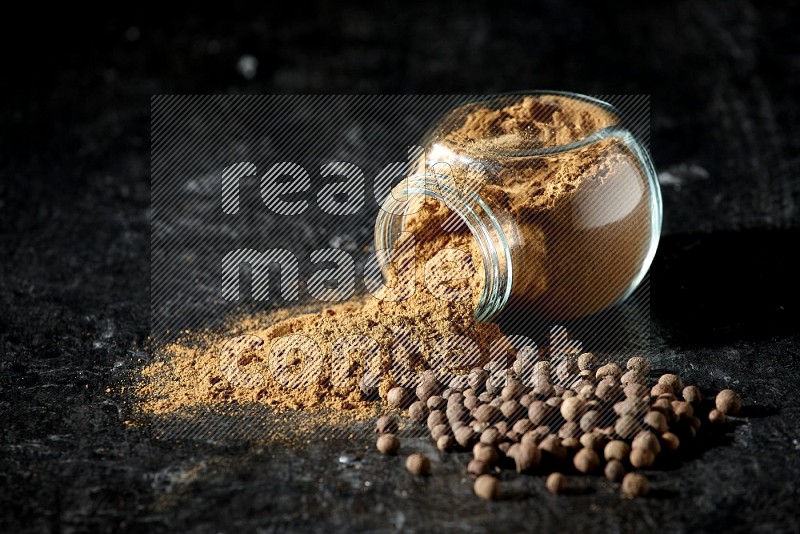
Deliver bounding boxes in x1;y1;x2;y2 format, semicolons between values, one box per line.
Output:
375;173;513;322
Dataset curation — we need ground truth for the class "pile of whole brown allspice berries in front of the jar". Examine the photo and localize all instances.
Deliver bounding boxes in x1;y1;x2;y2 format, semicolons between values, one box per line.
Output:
376;353;742;500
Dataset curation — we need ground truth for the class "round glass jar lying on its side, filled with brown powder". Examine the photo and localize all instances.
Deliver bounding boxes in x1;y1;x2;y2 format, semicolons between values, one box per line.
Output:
375;93;662;321
